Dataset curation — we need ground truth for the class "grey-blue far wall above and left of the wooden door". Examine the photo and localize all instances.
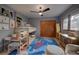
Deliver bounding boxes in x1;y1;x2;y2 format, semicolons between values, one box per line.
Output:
28;17;59;35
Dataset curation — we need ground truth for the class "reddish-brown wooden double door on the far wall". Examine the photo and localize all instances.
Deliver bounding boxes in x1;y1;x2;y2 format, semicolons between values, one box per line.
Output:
40;20;56;37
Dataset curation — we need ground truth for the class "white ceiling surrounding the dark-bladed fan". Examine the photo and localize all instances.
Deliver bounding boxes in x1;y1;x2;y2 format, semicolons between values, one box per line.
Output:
8;4;71;18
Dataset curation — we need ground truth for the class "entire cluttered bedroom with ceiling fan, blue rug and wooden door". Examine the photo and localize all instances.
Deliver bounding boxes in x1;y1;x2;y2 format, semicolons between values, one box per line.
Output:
0;4;79;55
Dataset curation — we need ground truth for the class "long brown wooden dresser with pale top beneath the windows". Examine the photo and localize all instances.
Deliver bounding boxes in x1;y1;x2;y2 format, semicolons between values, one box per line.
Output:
56;33;79;49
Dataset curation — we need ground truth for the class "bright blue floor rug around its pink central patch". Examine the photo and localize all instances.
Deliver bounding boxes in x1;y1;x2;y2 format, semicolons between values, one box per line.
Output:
28;37;58;55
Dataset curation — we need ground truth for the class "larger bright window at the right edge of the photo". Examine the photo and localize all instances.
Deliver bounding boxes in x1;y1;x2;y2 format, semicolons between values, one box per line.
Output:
70;14;79;31
